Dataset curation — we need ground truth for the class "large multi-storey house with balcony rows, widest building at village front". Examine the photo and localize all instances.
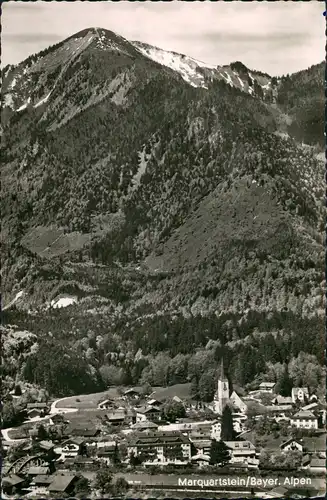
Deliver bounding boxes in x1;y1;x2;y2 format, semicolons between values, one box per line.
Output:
127;432;191;465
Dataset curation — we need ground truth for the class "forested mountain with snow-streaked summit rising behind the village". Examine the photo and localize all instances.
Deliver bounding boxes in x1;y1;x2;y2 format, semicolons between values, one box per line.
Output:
1;28;324;394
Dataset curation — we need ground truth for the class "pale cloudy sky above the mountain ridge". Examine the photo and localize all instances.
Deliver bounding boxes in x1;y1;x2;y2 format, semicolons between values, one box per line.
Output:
1;0;326;76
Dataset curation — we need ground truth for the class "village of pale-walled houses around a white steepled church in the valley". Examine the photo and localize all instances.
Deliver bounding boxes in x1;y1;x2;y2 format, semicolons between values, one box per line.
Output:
2;362;326;498
